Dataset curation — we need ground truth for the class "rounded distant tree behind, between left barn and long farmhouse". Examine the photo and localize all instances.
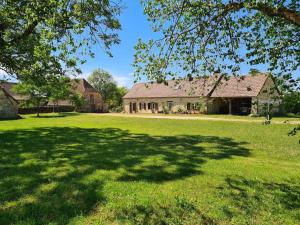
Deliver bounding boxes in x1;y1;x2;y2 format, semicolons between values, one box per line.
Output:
88;69;117;102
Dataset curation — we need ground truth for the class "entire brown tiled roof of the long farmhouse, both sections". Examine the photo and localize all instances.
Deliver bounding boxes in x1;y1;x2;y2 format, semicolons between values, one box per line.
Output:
123;74;268;99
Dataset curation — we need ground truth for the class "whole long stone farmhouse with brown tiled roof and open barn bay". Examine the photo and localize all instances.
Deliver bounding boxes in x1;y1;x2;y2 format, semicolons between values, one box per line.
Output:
123;74;281;115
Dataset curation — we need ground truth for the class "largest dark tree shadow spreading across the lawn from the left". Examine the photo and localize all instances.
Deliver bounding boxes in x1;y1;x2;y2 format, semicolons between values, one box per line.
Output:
0;127;249;224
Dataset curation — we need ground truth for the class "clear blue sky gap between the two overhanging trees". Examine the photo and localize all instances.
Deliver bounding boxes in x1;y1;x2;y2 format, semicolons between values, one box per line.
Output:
81;0;154;88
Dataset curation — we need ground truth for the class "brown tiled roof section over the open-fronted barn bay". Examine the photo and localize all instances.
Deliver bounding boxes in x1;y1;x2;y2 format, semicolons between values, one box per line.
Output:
211;74;268;97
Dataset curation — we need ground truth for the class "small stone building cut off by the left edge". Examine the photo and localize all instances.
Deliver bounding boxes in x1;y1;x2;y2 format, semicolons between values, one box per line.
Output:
0;86;18;119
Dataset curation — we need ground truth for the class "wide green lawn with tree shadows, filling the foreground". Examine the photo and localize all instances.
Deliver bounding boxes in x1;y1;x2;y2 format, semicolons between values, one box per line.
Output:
0;113;300;225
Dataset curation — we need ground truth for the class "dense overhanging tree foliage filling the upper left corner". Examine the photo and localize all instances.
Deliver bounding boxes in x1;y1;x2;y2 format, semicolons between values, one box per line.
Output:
0;0;121;80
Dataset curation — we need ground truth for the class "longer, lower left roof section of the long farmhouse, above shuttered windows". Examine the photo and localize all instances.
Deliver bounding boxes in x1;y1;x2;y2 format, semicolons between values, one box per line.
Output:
123;75;220;98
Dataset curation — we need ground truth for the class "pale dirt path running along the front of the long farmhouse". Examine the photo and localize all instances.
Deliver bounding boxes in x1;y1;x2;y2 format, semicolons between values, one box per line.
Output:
98;113;300;124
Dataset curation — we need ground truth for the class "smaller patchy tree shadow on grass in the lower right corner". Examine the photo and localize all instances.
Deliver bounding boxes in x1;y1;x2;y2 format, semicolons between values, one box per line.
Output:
219;176;300;221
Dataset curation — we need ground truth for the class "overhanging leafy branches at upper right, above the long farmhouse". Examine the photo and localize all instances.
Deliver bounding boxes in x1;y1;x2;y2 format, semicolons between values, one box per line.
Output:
134;0;300;88
